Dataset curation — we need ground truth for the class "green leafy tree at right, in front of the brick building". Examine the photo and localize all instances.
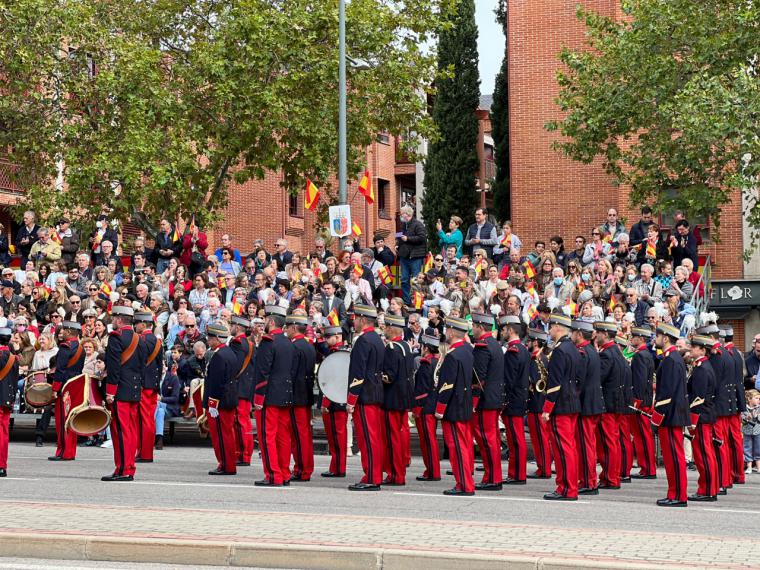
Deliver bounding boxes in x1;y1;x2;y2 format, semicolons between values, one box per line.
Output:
547;0;760;242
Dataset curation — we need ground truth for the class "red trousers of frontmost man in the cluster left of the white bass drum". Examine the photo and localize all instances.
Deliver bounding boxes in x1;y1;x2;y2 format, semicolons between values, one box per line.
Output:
256;406;290;485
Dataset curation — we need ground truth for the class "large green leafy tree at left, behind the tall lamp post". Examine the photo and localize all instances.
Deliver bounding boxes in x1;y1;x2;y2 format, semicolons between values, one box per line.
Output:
0;0;454;232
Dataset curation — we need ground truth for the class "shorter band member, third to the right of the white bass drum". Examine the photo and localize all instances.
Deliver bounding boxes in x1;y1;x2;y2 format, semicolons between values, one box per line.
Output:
412;335;441;481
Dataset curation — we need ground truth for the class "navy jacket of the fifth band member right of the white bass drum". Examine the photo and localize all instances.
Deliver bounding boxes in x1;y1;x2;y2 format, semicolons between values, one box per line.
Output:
472;333;505;410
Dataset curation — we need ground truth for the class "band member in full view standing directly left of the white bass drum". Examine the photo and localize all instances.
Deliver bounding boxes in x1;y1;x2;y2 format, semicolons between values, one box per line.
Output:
285;309;317;481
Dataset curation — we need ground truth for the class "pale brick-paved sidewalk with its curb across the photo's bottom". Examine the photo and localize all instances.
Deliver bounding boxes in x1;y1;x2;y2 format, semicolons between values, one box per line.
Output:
0;496;760;570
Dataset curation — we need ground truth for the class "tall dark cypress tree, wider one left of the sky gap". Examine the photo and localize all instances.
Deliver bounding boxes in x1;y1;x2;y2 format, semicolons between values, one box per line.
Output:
422;0;480;235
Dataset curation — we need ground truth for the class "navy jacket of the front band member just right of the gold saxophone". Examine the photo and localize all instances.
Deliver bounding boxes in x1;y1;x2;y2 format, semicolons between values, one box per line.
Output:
543;336;581;415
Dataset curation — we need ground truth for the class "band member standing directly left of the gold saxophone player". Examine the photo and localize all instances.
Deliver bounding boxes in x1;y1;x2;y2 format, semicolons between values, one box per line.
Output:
499;315;530;485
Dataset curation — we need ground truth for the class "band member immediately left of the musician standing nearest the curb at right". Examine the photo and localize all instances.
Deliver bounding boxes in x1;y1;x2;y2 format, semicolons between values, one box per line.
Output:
628;325;657;479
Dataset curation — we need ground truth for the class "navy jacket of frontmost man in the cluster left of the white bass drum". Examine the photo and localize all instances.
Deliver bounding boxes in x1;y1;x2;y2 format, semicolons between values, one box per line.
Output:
253;329;296;406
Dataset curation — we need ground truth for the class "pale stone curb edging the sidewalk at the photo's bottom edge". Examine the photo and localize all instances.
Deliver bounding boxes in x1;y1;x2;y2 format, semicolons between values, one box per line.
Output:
0;532;715;570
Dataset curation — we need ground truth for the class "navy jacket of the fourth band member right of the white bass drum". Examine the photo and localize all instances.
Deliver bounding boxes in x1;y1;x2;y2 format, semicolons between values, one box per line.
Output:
435;340;474;422
